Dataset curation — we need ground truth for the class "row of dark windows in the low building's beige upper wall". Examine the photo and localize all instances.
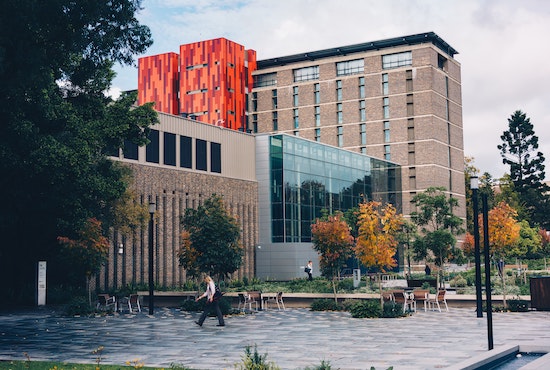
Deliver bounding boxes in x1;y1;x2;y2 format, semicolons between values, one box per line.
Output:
122;130;222;173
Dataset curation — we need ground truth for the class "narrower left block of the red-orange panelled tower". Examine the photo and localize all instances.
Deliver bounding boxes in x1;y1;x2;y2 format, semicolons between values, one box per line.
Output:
138;53;179;114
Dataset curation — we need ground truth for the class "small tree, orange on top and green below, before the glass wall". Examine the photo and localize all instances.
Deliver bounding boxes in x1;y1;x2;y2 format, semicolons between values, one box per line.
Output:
311;213;354;301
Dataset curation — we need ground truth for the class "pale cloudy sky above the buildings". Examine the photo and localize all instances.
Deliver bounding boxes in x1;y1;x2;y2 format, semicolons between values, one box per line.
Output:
113;0;550;180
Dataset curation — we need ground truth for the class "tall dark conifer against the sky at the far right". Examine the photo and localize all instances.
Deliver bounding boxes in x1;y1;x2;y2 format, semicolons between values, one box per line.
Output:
497;110;550;225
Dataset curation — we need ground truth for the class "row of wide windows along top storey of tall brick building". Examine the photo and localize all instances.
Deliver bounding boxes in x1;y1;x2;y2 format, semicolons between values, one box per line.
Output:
254;51;412;87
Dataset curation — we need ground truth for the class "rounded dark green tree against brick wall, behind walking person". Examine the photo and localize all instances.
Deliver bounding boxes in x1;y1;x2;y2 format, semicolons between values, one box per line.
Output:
178;194;244;280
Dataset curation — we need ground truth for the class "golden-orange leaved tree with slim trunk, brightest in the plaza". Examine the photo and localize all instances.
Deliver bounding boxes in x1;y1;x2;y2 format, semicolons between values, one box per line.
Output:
355;201;403;305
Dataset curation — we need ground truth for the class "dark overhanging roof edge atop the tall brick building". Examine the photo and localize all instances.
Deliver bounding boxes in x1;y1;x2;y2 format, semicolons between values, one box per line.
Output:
257;32;458;69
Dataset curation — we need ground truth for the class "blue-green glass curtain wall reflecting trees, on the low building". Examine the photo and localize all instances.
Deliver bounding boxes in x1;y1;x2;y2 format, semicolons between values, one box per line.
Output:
270;135;401;243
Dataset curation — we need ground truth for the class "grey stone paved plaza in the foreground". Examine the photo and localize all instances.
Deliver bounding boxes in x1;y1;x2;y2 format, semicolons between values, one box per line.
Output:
0;307;550;370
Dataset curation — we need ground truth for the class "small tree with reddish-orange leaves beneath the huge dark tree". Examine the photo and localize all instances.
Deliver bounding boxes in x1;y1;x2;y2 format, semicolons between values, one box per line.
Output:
57;218;109;305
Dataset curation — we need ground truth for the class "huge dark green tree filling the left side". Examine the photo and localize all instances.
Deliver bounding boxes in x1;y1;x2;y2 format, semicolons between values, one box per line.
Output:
0;0;157;299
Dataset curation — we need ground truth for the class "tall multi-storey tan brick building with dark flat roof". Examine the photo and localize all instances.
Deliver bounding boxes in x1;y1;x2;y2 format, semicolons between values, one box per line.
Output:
253;32;466;218
